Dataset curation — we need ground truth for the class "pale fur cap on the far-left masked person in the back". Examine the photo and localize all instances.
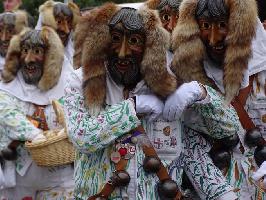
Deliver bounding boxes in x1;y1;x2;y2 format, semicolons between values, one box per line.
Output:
0;10;29;34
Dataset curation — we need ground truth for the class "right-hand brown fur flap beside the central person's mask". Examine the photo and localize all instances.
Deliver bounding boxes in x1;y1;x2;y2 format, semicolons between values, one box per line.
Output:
138;8;176;97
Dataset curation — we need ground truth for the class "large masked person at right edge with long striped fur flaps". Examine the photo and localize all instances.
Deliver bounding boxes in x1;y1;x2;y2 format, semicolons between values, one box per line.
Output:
168;0;265;199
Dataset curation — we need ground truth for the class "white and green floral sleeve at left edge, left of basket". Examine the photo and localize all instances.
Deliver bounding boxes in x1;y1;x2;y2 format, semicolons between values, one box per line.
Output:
0;91;41;150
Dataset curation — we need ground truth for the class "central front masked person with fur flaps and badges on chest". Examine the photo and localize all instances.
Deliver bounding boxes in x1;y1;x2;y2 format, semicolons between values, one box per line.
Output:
64;4;239;200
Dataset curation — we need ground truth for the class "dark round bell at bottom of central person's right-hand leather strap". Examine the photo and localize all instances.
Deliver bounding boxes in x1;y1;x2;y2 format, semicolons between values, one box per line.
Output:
158;179;178;200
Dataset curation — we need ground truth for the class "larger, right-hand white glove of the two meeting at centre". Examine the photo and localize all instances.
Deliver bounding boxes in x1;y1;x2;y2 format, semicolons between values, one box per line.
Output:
163;81;206;121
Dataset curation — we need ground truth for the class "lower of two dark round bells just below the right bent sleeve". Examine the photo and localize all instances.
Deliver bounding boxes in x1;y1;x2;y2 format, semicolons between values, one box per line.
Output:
209;149;231;170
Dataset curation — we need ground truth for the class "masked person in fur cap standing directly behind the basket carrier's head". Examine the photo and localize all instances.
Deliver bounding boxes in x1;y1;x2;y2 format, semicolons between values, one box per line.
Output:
35;0;80;65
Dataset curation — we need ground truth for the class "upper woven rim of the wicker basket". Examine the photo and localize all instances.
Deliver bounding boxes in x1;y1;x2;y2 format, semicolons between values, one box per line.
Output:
25;131;68;149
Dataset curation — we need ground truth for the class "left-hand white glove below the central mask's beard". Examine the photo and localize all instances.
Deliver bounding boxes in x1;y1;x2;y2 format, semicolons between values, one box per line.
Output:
136;94;163;122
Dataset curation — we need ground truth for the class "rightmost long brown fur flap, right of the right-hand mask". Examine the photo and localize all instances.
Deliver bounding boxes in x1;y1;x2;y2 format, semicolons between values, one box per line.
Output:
224;0;258;102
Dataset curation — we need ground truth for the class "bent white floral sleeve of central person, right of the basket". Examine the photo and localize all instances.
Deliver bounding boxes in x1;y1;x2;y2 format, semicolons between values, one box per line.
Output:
64;88;140;153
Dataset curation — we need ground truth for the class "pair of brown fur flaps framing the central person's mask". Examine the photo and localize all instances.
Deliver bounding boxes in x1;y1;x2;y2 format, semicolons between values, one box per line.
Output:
74;3;176;115
